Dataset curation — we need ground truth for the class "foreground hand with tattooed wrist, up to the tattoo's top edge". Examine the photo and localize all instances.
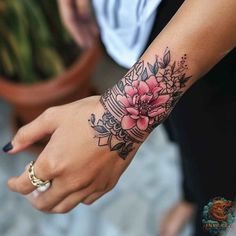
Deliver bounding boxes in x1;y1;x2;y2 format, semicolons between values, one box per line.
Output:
5;48;194;213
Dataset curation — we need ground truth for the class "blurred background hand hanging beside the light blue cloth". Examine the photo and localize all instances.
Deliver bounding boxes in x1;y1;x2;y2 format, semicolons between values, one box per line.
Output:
58;0;99;48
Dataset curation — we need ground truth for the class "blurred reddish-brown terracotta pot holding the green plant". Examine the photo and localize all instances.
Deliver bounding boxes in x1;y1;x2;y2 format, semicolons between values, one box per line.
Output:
0;43;101;124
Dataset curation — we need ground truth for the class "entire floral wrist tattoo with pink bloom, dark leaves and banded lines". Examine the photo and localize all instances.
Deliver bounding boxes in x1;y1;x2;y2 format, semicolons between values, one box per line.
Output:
89;48;191;159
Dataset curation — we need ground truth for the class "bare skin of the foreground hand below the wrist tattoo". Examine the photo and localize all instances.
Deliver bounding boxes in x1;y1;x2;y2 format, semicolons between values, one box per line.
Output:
8;96;137;213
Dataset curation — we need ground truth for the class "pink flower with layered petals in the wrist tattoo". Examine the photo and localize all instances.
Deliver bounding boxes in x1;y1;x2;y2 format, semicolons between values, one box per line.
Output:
117;75;170;130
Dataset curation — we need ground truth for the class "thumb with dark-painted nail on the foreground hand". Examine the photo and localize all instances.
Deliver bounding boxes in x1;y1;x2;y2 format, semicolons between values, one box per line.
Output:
3;108;57;154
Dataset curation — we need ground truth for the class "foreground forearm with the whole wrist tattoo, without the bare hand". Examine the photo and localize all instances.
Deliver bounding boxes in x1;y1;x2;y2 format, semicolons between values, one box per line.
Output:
90;0;236;158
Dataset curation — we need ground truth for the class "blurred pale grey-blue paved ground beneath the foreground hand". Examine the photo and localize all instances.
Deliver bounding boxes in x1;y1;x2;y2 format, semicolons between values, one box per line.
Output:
0;54;235;236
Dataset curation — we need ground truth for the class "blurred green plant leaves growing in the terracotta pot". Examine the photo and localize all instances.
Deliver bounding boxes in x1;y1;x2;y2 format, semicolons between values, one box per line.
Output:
0;0;79;83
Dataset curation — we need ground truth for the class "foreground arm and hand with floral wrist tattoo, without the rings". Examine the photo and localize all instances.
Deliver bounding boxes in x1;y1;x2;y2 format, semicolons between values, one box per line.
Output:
8;0;236;213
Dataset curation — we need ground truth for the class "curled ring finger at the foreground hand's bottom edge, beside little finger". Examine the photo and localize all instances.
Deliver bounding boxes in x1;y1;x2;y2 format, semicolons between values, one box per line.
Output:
50;186;94;213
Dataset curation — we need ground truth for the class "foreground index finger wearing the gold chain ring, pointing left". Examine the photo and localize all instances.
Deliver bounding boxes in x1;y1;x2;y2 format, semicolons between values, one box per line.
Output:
7;142;57;195
